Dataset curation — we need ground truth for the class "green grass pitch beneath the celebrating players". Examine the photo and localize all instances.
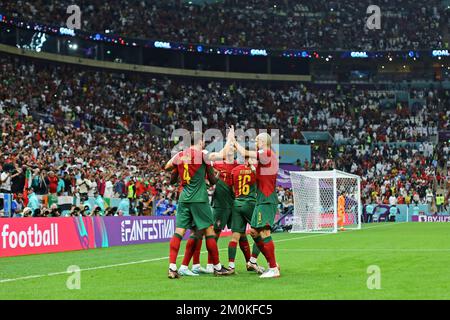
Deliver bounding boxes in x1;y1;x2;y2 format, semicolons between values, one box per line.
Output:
0;223;450;300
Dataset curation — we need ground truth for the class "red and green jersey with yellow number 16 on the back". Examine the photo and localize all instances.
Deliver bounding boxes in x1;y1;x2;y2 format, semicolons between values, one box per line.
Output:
231;164;256;207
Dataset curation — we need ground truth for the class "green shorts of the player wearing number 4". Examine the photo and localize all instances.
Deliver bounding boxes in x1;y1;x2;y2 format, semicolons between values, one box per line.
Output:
176;202;214;230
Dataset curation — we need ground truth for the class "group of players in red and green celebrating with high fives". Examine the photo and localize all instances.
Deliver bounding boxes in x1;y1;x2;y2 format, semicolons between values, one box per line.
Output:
165;127;280;279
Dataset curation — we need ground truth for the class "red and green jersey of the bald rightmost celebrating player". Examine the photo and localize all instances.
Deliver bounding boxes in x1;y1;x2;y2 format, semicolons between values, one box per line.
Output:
256;150;279;204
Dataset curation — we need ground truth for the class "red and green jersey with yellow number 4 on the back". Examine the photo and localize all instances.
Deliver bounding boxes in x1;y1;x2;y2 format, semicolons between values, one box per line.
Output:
174;147;212;202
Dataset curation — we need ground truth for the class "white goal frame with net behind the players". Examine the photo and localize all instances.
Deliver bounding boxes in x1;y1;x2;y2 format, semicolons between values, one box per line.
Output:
290;170;362;233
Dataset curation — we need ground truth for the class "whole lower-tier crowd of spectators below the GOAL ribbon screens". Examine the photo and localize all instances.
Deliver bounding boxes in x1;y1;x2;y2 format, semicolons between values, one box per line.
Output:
0;57;450;215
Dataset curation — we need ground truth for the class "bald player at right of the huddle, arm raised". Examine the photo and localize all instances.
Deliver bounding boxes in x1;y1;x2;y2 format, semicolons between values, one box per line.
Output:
235;133;280;278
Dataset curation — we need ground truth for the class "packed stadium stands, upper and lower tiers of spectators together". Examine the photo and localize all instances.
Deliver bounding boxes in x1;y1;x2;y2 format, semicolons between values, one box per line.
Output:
0;0;450;219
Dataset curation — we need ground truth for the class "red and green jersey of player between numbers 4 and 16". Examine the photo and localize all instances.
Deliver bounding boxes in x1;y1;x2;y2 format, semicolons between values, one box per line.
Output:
211;162;236;208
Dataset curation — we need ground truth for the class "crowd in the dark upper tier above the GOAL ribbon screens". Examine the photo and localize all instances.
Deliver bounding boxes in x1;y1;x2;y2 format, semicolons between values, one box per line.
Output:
0;0;447;50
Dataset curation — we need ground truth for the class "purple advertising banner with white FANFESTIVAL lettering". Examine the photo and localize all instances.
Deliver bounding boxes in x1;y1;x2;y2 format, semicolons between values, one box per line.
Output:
103;217;175;246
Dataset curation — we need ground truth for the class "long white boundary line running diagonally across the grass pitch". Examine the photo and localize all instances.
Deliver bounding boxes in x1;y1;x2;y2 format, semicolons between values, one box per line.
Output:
0;222;404;283
